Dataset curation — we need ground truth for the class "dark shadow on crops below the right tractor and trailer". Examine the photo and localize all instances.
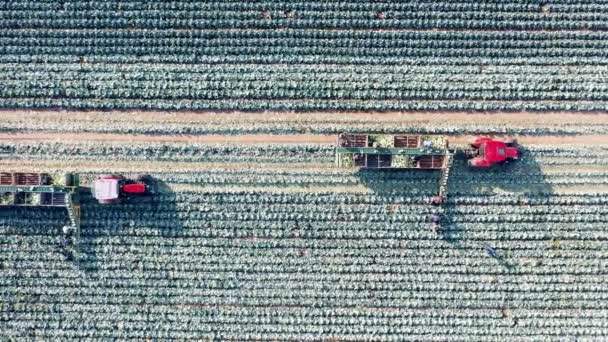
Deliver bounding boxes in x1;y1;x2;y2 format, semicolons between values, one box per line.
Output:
355;147;553;254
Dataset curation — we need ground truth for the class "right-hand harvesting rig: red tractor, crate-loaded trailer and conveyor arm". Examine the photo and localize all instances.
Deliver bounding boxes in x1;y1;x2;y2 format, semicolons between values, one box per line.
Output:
336;133;519;229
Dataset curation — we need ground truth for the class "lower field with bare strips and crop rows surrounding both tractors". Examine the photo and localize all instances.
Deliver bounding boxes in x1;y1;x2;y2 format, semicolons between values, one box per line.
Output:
0;111;608;341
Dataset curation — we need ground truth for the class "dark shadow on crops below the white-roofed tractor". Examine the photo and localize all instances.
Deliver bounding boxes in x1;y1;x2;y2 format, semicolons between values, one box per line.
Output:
80;178;184;272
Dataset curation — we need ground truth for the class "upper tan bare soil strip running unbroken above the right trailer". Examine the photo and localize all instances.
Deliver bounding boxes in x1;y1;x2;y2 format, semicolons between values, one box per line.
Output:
0;110;608;127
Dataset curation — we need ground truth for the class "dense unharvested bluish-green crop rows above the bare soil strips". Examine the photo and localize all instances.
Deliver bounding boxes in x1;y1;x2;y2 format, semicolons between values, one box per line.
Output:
0;0;608;111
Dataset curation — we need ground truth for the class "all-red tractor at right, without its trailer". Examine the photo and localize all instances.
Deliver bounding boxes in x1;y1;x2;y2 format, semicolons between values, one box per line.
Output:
469;137;519;167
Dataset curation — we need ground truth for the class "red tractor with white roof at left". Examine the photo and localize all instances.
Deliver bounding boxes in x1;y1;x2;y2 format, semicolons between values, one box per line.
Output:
92;175;152;204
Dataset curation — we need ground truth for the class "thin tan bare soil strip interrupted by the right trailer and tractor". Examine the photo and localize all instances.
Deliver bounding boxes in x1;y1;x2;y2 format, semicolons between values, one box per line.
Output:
0;133;608;145
